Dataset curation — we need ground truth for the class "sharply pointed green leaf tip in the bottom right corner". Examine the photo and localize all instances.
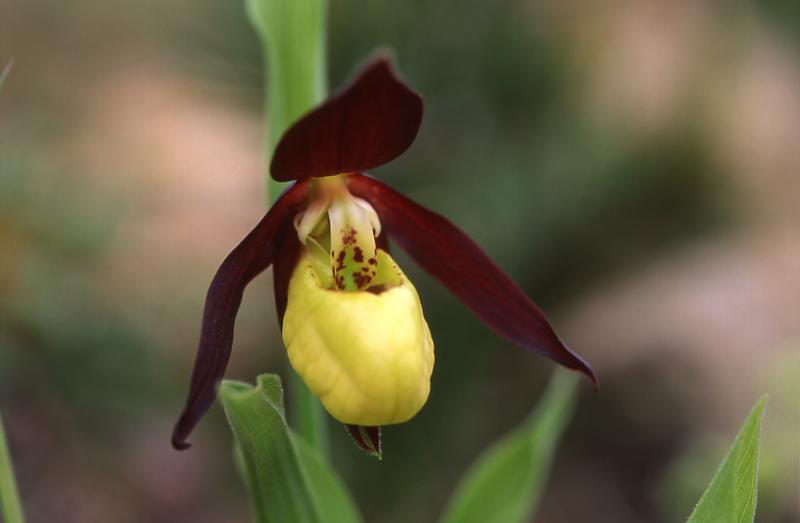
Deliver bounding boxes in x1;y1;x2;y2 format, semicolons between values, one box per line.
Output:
688;396;767;523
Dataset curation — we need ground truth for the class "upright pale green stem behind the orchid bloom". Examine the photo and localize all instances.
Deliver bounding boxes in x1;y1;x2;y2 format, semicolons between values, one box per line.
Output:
246;0;328;457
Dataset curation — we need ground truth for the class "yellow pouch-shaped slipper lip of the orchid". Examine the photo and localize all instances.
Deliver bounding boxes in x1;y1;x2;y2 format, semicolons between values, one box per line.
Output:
283;250;434;426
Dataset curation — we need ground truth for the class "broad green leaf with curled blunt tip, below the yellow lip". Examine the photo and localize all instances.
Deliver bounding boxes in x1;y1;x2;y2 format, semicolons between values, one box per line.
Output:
220;374;361;523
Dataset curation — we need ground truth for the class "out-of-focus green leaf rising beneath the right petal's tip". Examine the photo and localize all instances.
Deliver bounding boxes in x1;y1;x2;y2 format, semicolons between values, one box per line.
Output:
442;371;578;523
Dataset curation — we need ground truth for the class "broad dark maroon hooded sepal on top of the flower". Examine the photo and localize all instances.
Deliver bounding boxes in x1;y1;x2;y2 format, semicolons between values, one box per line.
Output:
270;57;422;181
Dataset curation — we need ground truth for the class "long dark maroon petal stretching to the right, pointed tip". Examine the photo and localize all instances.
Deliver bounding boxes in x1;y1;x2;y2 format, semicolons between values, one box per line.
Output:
348;174;597;388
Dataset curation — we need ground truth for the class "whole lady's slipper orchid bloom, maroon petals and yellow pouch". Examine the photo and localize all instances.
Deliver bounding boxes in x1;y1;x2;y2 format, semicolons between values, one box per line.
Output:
172;54;596;451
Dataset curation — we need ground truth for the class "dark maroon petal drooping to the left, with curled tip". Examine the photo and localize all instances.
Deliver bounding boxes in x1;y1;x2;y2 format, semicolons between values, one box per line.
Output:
172;182;309;450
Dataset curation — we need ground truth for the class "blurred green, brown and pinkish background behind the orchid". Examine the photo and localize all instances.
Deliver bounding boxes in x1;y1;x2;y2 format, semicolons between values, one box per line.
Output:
0;0;800;523
